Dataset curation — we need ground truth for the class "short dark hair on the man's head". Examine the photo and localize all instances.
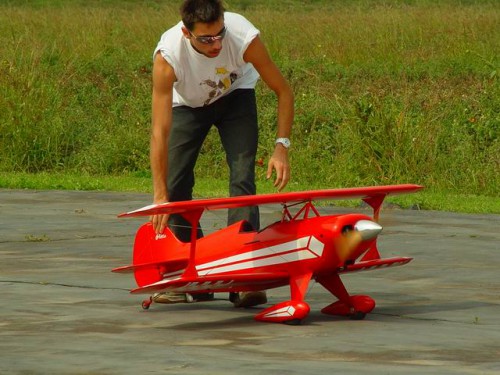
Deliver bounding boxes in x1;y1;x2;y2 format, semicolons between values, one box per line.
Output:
180;0;225;31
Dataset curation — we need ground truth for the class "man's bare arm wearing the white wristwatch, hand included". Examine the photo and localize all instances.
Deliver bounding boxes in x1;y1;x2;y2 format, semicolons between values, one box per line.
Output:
243;36;294;190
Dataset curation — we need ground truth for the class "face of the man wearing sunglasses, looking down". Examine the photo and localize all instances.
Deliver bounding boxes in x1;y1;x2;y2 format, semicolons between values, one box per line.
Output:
182;18;226;58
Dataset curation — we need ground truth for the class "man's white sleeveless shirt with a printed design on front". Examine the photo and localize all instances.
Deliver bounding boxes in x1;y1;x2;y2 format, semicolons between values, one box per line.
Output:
153;12;259;107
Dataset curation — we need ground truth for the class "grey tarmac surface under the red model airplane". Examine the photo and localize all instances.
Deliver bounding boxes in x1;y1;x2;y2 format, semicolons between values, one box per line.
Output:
0;190;500;375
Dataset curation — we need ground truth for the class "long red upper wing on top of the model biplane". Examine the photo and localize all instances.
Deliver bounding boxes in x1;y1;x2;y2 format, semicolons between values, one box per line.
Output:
118;184;423;217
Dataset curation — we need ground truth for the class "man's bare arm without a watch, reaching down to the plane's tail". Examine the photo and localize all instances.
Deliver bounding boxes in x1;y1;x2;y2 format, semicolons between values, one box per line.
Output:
150;53;176;233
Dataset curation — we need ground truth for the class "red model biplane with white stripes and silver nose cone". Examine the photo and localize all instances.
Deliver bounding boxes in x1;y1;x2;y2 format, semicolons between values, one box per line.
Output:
113;185;422;324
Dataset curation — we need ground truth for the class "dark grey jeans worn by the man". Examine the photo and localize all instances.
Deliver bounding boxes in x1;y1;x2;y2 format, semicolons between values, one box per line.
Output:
167;89;259;242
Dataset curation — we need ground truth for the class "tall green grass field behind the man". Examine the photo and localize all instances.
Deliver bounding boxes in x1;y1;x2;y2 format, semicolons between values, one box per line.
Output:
0;0;500;212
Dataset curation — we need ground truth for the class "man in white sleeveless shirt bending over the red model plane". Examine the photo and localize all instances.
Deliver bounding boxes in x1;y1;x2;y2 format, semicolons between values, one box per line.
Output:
150;0;294;307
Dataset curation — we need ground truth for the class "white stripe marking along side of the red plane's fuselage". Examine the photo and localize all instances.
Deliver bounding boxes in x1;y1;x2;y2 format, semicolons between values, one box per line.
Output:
196;236;325;276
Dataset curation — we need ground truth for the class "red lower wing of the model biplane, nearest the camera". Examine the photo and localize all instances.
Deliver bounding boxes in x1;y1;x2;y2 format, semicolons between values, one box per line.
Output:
131;272;290;294
